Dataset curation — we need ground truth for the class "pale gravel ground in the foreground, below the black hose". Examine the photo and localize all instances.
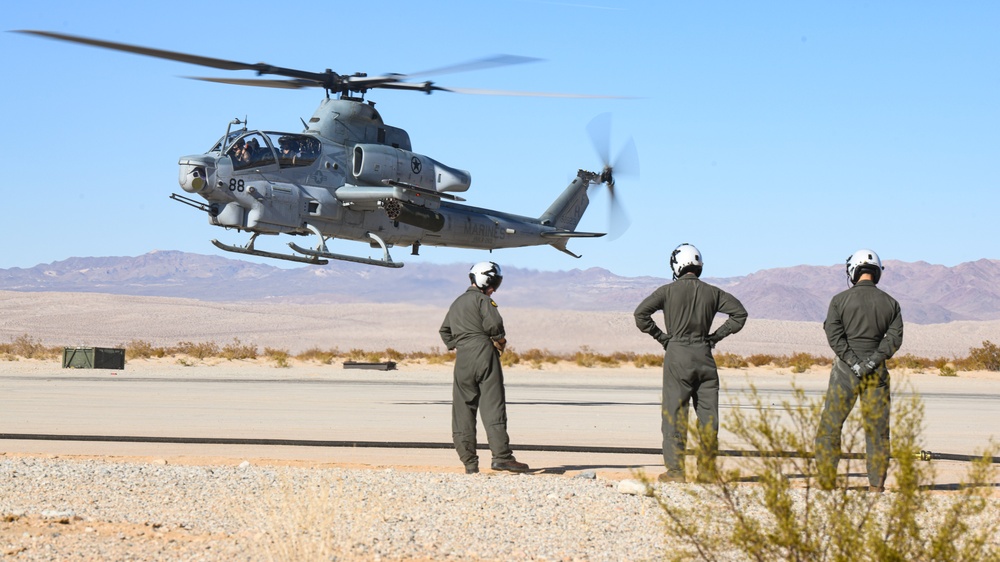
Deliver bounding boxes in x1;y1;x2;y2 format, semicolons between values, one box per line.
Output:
0;455;1000;560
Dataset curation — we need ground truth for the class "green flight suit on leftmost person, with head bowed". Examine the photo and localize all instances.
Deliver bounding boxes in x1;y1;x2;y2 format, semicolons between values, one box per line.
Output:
440;286;514;468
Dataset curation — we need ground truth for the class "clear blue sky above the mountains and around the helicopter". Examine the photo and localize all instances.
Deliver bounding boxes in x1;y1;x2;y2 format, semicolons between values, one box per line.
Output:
0;0;1000;277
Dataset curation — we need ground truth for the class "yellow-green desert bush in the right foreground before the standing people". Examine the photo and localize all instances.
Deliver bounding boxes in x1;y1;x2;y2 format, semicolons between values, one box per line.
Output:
643;380;1000;561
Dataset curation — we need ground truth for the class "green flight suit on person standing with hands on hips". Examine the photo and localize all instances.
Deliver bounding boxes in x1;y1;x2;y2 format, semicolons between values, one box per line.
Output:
635;273;747;477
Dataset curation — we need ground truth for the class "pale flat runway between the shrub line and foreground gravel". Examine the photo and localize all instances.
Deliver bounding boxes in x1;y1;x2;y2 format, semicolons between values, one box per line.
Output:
0;364;1000;484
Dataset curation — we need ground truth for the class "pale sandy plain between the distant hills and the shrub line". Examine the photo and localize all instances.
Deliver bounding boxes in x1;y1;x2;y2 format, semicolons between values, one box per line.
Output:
0;291;1000;358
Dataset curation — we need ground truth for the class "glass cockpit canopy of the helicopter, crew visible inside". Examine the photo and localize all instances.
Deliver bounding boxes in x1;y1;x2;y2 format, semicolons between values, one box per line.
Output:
209;130;321;170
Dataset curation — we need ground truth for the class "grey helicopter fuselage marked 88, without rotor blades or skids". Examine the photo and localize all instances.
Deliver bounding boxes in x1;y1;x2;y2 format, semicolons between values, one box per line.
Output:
172;99;594;264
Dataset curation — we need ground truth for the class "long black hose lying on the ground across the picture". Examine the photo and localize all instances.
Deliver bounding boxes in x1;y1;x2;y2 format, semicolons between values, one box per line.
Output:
0;433;1000;464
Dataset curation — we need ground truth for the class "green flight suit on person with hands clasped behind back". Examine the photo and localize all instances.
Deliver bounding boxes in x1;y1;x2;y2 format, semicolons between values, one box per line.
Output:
815;280;903;489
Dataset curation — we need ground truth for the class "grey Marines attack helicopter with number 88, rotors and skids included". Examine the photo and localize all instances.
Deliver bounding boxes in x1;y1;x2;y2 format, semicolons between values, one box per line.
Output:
18;30;637;268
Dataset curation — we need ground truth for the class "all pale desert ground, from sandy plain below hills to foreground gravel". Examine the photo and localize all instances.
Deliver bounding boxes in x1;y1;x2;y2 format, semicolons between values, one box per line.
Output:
0;292;1000;560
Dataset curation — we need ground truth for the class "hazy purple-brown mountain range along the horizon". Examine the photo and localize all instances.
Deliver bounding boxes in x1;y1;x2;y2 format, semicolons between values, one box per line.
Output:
0;251;1000;324
